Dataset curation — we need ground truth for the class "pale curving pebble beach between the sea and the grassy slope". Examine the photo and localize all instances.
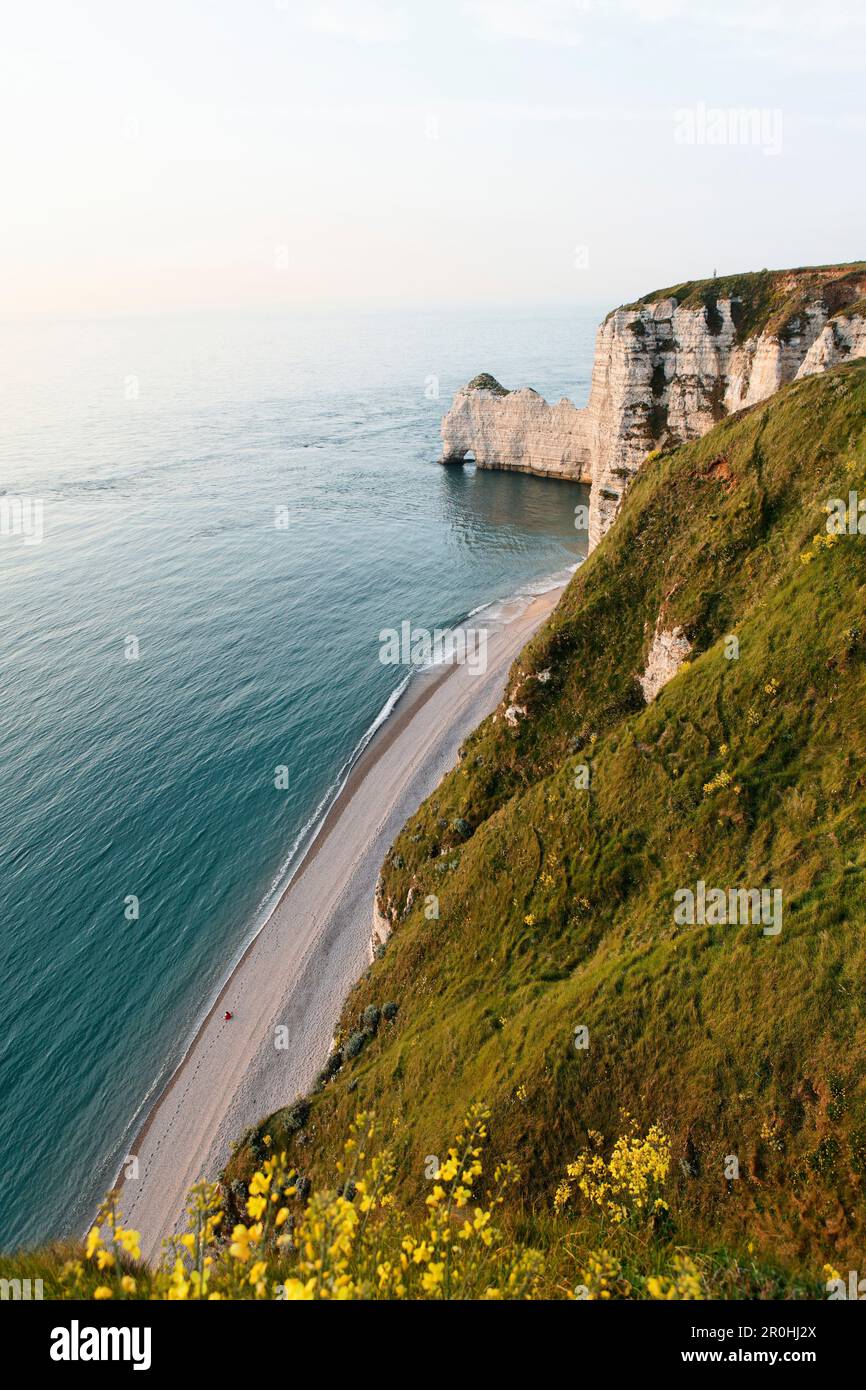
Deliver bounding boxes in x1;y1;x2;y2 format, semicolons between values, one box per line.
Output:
115;573;571;1259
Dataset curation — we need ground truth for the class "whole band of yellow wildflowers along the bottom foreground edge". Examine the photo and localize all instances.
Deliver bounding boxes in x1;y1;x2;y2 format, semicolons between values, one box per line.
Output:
21;1105;800;1301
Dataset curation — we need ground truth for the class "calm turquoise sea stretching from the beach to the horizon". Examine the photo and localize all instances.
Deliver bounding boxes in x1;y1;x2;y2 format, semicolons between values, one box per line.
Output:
0;310;598;1247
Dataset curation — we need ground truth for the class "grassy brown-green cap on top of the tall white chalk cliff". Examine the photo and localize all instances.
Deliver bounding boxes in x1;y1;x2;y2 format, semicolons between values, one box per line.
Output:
617;261;866;342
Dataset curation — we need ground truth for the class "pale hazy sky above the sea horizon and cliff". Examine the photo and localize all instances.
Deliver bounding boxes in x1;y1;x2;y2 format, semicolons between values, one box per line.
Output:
0;0;866;317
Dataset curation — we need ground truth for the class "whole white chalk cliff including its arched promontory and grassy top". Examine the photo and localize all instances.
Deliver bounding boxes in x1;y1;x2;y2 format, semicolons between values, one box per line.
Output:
442;263;866;549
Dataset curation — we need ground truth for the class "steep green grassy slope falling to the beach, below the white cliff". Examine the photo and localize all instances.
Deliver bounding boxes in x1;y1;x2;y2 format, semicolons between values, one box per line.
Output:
239;363;866;1269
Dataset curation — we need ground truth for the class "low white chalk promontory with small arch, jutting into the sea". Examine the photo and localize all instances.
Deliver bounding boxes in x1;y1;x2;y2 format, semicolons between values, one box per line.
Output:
442;375;589;482
